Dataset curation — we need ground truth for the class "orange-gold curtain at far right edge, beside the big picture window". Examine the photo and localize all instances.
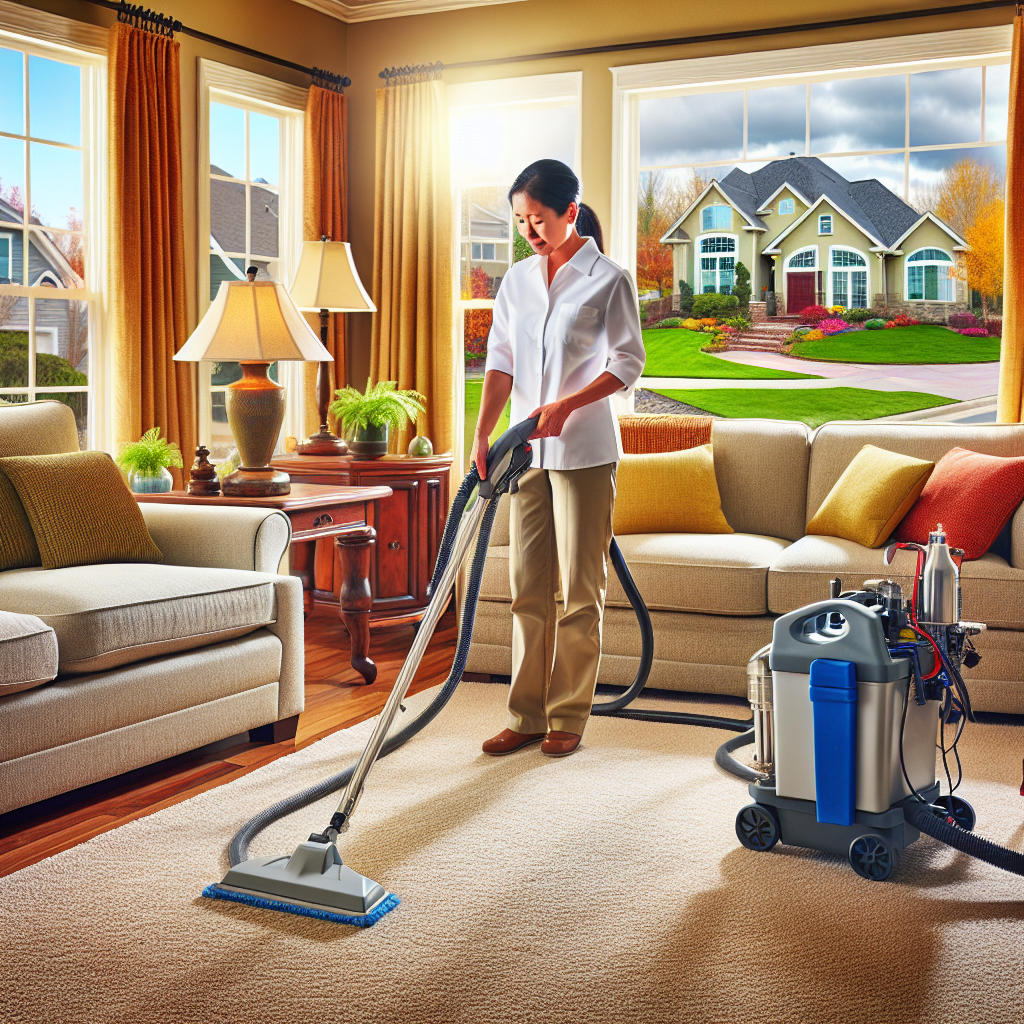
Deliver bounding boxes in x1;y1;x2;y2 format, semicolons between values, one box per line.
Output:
996;6;1024;423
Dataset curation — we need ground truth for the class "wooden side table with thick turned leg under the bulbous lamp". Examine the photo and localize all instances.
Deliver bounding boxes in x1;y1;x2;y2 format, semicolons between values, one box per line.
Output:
135;483;391;683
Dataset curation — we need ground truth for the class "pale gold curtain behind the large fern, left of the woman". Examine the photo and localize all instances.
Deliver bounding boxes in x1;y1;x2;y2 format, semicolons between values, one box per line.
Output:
370;80;455;453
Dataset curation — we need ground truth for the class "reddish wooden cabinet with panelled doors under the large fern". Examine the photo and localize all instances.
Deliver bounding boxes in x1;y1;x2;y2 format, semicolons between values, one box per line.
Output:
273;455;452;629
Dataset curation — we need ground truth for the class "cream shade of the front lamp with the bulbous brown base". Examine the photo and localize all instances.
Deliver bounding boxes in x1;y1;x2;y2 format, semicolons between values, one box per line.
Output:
174;281;333;362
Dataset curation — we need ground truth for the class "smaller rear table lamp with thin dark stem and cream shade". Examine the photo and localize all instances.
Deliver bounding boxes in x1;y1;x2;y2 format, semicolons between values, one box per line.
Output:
292;234;377;455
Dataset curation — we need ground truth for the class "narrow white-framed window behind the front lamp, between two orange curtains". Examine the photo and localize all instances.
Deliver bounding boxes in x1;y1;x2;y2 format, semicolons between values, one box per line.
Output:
193;60;306;459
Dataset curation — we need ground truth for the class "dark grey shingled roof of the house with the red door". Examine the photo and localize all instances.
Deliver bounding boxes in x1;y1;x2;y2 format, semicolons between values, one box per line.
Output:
719;157;933;246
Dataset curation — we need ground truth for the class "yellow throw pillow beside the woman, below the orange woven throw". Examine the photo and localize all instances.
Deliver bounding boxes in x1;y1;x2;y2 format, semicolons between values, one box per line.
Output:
611;444;734;536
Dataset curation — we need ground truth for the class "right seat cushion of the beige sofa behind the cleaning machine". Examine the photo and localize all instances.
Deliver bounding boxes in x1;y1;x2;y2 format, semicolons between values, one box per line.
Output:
768;537;1024;630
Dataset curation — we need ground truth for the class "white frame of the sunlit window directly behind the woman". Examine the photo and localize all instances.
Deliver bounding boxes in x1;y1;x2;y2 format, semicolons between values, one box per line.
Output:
445;71;585;473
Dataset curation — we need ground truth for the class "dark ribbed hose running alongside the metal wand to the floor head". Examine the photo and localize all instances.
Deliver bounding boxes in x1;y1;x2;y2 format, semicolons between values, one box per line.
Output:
227;485;498;867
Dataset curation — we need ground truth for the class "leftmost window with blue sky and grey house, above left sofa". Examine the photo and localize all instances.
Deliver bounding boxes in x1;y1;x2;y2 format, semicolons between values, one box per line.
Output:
0;27;105;449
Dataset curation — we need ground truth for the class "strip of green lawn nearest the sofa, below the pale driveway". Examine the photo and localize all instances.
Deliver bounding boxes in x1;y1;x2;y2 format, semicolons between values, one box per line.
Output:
657;385;955;427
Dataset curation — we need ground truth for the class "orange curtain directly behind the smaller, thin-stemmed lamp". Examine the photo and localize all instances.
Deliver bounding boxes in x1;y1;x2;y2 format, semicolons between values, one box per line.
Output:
302;85;348;436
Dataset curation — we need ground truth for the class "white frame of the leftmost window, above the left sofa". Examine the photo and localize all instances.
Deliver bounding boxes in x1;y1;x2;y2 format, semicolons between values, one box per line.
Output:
0;0;105;452
